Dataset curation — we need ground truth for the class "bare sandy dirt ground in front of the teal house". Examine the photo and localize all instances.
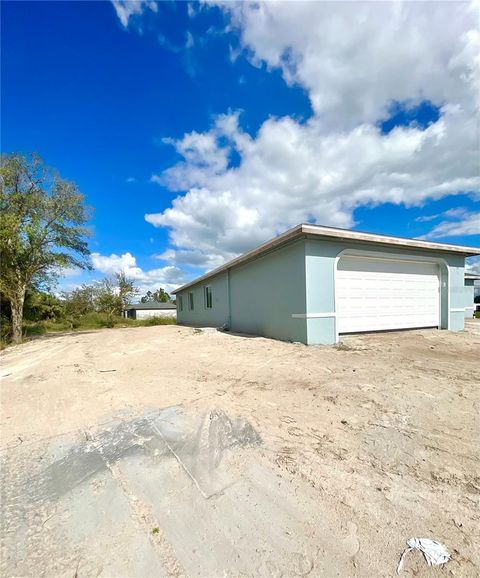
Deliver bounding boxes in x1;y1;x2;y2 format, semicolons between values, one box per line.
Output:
0;321;480;578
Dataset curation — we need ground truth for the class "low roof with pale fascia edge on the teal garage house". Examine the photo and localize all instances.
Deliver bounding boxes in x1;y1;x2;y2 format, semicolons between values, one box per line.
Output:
172;224;480;293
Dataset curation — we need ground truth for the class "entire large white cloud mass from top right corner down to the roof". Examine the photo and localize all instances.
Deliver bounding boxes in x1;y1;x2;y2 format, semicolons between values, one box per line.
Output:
145;1;480;268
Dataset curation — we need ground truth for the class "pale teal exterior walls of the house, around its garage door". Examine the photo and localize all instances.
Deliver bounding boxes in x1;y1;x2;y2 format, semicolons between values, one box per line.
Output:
177;237;473;345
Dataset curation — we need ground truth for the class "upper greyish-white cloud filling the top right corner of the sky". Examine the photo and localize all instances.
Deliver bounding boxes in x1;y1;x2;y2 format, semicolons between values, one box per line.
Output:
218;1;480;129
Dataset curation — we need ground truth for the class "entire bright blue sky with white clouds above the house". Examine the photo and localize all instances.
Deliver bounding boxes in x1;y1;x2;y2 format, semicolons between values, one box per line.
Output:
1;1;480;289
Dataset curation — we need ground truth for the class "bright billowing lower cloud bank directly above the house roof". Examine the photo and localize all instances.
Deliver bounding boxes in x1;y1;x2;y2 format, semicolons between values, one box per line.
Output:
146;104;480;262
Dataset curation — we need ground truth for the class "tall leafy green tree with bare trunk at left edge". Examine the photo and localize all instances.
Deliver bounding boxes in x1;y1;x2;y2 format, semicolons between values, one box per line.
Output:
0;154;90;343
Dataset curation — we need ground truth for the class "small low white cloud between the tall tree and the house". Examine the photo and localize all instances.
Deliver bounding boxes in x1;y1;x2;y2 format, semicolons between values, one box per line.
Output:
92;252;185;293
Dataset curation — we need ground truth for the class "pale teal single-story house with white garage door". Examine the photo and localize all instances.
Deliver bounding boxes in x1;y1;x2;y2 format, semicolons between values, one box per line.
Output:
175;225;480;344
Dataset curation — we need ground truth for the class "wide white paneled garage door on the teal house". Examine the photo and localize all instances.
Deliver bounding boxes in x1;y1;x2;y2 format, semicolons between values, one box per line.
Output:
335;256;440;333
